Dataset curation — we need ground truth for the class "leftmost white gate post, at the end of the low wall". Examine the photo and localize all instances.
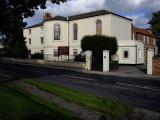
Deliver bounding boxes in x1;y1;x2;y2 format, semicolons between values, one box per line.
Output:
86;50;92;70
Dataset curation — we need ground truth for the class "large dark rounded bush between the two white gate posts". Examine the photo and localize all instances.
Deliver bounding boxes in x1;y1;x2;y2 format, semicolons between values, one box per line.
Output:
81;35;118;70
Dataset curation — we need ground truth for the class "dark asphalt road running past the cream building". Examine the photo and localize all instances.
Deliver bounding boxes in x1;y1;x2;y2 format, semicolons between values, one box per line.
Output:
0;62;160;112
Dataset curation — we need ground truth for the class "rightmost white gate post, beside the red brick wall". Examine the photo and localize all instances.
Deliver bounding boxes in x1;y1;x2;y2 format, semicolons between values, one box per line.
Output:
147;49;154;75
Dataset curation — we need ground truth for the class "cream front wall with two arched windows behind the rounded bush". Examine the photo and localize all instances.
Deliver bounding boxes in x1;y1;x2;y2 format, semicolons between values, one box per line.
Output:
69;14;111;55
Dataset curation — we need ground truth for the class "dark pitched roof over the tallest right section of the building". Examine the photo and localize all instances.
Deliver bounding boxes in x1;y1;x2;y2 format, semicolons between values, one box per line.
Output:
69;10;132;21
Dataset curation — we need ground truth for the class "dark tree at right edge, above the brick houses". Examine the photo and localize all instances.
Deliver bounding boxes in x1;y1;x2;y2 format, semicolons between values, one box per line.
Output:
149;11;160;52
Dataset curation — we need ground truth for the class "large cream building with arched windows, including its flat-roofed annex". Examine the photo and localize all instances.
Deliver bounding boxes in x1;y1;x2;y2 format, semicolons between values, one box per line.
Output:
24;10;144;64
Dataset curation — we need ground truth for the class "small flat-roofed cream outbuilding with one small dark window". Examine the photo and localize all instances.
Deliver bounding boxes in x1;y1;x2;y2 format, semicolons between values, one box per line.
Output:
117;40;144;64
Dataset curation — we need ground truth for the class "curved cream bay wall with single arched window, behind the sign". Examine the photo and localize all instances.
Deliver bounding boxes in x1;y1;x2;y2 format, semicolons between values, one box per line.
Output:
44;20;68;60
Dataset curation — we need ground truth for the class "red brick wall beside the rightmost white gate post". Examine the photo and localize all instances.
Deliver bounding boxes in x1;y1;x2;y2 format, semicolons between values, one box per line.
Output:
153;57;160;75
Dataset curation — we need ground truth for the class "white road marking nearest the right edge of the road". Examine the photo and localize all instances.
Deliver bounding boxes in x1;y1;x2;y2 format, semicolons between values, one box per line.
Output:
116;82;160;92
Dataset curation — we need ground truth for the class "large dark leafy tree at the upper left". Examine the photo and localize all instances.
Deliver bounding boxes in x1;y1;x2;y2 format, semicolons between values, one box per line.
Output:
0;0;66;57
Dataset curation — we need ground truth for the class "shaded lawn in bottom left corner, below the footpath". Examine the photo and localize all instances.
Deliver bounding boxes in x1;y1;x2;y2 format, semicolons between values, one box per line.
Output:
0;83;79;120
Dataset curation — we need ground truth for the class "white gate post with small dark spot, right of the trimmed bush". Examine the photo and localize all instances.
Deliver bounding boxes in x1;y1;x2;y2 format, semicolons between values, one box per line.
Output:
103;50;109;72
